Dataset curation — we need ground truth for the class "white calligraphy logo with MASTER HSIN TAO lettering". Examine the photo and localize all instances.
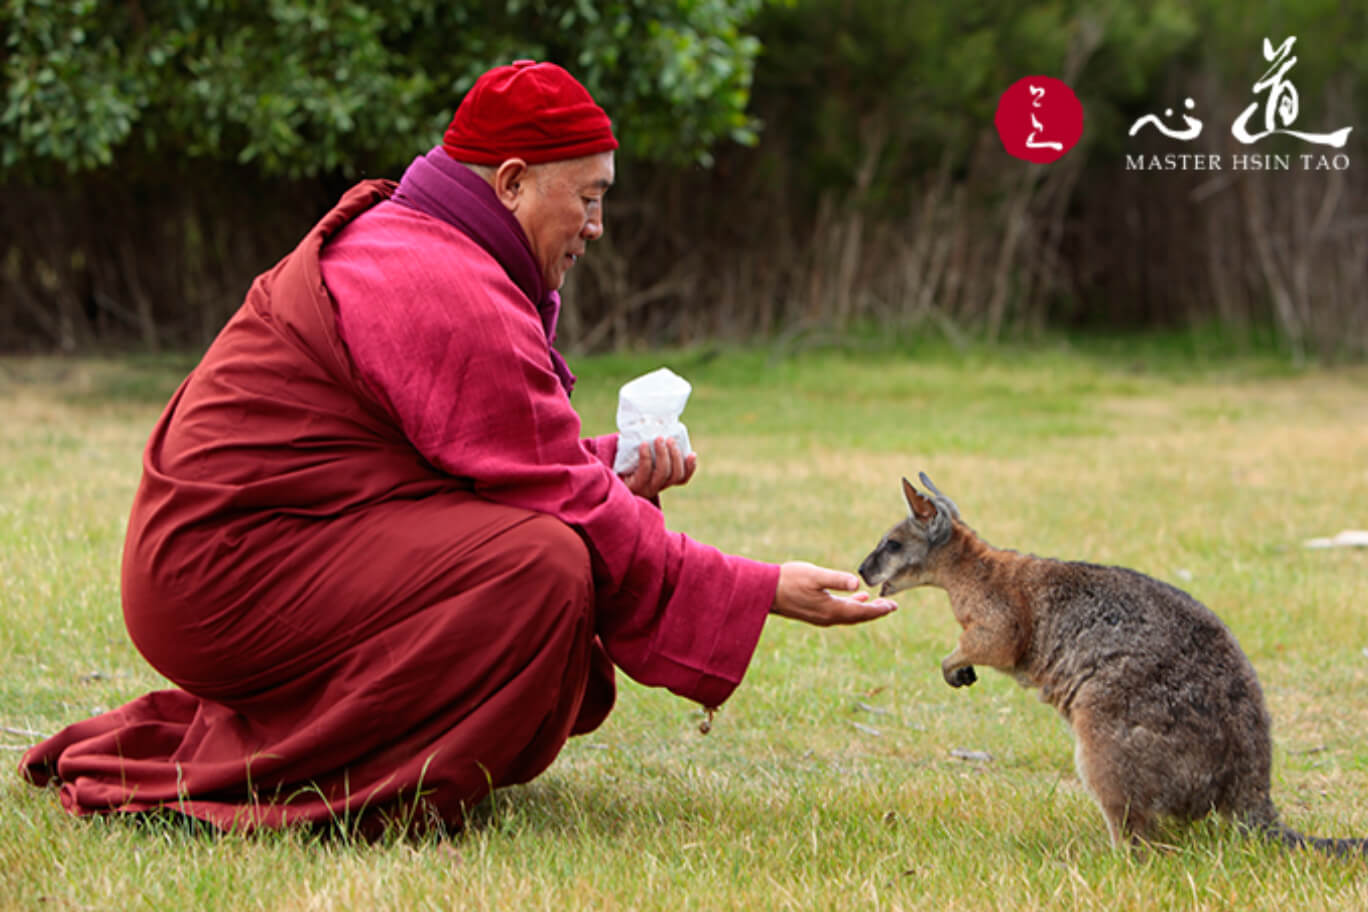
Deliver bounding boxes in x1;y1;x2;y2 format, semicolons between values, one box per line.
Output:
1126;36;1353;171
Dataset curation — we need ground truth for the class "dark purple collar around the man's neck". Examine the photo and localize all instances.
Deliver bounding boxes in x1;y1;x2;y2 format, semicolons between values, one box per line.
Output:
391;146;575;395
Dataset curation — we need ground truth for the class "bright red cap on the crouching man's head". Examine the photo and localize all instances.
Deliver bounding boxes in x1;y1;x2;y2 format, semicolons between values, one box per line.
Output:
442;60;617;164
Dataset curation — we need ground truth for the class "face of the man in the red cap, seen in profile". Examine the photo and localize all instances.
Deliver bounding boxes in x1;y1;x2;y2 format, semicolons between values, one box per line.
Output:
513;152;613;289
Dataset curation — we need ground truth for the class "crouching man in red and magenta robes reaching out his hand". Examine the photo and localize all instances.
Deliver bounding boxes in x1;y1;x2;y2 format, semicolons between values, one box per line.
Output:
21;60;896;833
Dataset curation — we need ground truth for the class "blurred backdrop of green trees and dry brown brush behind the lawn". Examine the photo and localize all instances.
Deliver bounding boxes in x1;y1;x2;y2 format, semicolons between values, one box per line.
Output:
0;0;1368;356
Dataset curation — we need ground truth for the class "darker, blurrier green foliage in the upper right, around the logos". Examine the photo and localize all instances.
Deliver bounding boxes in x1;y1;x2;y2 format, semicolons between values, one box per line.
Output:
755;0;1368;203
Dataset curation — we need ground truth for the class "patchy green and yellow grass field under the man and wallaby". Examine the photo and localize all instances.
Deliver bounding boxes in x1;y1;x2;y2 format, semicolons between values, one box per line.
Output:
0;340;1368;912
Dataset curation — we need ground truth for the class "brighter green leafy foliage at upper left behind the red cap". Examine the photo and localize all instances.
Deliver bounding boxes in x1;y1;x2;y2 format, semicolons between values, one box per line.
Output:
0;0;759;178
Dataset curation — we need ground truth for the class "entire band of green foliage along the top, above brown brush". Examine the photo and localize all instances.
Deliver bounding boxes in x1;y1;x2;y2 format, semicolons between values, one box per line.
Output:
0;0;1368;188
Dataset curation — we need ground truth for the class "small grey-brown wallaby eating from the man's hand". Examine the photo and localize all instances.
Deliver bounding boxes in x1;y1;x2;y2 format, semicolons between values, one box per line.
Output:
859;473;1368;853
